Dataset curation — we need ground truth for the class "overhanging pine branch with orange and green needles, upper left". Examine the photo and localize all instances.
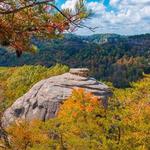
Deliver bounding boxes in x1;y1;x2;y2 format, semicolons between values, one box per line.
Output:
0;0;89;56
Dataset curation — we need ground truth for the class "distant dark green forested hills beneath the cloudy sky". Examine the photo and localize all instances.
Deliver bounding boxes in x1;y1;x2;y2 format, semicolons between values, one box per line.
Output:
0;34;150;87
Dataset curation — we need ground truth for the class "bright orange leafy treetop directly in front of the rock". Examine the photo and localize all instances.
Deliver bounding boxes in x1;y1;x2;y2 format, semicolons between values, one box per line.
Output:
58;89;100;119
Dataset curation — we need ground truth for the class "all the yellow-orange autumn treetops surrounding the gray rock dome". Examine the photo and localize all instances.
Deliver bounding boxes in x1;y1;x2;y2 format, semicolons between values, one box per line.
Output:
0;65;150;150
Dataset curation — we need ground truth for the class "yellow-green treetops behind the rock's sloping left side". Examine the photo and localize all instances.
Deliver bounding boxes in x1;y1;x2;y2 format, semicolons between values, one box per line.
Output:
0;64;69;112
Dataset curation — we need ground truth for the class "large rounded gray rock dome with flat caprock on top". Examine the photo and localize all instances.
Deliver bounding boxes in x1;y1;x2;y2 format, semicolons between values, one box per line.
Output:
2;69;111;127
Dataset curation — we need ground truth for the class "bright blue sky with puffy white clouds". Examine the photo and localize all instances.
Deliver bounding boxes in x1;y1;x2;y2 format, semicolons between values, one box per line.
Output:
57;0;150;35
